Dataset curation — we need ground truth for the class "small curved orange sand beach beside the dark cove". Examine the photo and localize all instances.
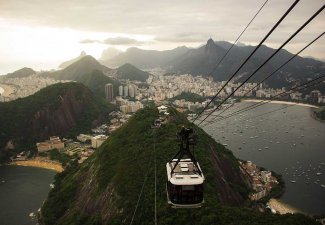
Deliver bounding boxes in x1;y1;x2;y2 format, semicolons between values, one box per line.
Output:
8;158;64;173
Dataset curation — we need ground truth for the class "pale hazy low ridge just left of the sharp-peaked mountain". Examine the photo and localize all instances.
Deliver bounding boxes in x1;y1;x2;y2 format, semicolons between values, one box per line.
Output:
102;46;188;69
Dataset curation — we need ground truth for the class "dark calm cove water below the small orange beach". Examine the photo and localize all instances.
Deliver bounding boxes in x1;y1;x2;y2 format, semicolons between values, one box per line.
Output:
0;166;56;225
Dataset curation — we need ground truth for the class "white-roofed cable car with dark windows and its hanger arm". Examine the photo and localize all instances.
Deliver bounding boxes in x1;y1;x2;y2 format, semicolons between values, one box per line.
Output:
166;127;204;208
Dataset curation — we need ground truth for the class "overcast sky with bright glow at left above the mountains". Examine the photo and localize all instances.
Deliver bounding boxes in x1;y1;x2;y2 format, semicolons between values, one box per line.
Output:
0;0;325;74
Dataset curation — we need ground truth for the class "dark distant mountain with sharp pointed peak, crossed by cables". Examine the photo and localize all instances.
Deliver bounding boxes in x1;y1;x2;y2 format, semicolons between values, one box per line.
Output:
169;39;325;87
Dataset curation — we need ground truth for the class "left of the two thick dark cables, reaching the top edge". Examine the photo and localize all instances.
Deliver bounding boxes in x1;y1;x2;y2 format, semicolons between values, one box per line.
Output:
193;0;300;123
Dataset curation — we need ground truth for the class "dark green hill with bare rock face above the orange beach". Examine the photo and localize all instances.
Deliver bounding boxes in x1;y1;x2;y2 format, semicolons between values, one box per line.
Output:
0;82;113;161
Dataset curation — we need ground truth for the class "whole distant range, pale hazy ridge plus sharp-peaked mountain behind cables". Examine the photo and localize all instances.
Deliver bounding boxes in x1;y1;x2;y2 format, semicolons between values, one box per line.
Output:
107;39;325;88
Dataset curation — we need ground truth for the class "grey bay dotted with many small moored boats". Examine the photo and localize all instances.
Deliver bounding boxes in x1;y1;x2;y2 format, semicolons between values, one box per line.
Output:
203;102;325;215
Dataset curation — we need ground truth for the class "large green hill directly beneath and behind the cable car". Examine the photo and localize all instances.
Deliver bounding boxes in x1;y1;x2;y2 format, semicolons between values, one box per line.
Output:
40;108;316;225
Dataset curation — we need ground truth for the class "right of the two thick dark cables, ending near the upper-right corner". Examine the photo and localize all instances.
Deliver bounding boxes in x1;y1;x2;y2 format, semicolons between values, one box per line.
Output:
198;5;325;125
